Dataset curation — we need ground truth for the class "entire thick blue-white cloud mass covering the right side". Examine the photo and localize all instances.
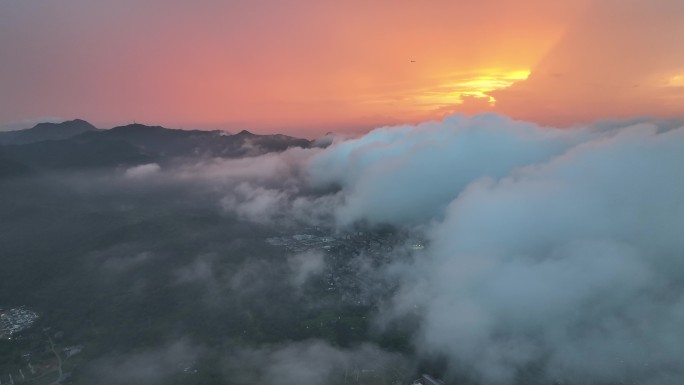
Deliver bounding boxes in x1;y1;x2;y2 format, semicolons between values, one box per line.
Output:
311;116;684;384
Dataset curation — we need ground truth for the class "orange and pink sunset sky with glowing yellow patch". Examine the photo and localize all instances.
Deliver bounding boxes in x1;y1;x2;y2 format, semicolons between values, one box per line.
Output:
0;0;684;136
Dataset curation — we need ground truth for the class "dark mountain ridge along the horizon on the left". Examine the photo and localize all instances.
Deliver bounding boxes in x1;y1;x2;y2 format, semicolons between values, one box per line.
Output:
0;119;313;178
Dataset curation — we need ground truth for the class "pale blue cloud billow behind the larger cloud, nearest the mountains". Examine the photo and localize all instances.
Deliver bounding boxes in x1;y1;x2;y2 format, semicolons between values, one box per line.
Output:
310;115;588;224
